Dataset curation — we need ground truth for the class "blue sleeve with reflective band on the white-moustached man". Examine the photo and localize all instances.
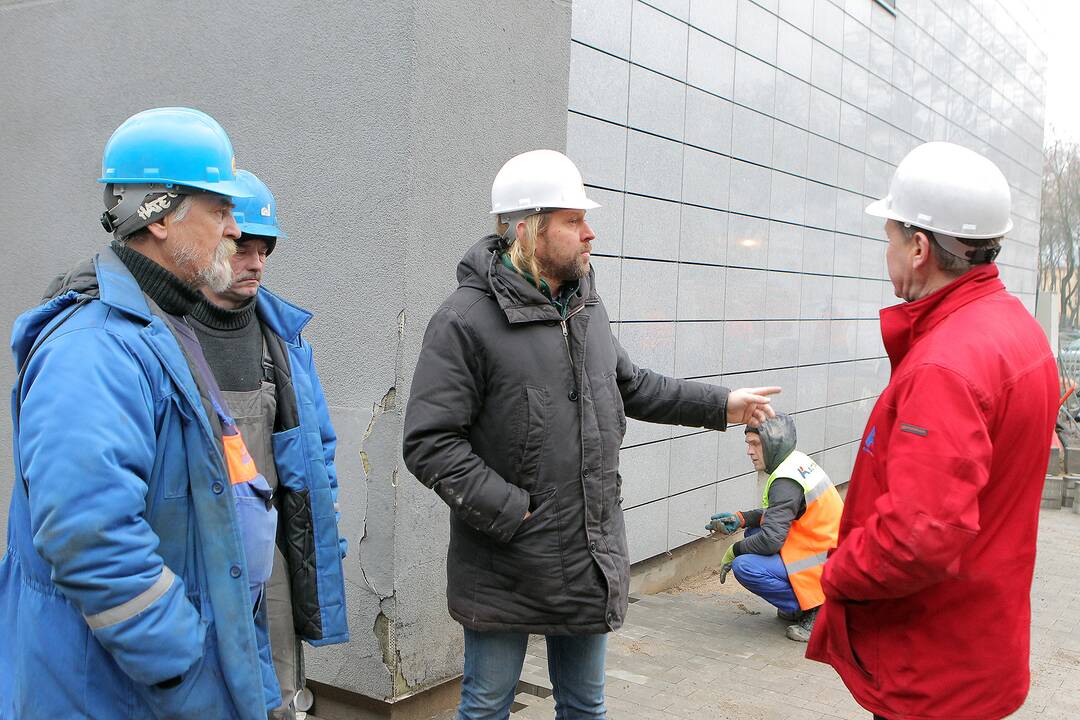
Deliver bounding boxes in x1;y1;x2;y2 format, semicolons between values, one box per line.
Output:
16;328;206;684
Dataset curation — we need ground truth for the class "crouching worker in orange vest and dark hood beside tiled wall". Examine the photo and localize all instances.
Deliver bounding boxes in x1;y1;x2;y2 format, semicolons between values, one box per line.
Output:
705;415;843;642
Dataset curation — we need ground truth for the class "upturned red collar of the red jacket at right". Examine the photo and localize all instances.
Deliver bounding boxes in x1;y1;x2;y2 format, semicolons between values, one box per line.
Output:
879;262;1005;371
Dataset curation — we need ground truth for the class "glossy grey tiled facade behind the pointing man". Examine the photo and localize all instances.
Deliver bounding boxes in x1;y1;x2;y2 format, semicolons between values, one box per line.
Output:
567;0;1045;561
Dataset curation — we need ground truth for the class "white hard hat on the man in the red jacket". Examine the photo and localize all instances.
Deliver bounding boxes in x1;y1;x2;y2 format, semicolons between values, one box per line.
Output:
866;142;1012;240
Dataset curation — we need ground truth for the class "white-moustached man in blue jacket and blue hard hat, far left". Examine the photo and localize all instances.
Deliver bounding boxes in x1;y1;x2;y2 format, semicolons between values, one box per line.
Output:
0;108;335;720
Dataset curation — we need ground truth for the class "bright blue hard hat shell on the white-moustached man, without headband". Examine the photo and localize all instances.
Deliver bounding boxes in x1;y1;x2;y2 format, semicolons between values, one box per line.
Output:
97;108;251;198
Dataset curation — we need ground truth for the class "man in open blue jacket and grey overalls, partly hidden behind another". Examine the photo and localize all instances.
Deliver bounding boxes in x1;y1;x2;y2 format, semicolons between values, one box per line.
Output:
189;171;348;720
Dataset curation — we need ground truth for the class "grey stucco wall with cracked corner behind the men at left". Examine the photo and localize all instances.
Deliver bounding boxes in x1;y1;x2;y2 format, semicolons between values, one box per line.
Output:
0;0;570;697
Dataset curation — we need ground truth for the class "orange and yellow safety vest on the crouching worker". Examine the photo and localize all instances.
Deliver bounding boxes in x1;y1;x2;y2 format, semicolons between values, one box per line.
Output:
761;450;843;610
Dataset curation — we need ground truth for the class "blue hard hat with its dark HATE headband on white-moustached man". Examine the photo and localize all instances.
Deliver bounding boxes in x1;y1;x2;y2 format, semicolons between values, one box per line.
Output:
97;108;251;239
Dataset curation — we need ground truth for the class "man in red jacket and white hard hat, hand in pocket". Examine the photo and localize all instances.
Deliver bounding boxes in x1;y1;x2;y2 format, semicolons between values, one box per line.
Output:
807;142;1058;720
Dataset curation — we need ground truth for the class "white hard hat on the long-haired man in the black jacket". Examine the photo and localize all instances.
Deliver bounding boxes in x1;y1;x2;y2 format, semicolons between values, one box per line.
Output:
491;150;599;216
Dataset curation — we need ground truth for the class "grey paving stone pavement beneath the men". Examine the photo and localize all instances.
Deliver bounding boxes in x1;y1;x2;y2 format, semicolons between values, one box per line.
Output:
511;510;1080;720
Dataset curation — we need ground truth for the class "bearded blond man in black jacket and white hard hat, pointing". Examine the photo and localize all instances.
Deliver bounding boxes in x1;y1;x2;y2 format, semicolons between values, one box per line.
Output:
404;150;780;720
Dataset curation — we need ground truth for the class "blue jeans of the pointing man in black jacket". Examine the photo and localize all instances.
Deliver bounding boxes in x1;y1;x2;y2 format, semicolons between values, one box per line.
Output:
458;628;607;720
